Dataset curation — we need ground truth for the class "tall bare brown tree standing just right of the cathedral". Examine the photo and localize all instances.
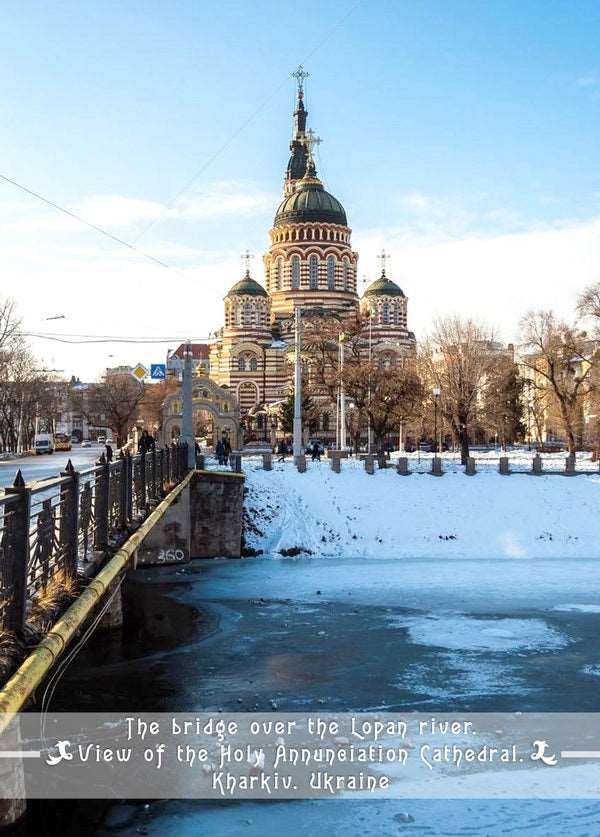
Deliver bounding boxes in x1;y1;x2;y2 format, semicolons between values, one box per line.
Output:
421;316;498;463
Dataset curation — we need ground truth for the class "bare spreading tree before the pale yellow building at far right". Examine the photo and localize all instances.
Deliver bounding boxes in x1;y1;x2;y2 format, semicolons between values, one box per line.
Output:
521;311;595;453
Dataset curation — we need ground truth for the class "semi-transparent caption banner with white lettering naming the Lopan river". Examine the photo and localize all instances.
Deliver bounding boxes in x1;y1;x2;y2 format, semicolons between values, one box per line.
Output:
0;712;600;799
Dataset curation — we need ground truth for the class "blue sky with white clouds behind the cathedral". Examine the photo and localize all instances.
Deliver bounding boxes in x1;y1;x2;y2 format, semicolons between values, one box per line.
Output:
0;0;600;376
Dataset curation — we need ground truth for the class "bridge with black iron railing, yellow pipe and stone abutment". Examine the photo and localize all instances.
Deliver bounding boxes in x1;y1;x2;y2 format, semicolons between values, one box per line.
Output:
0;442;244;829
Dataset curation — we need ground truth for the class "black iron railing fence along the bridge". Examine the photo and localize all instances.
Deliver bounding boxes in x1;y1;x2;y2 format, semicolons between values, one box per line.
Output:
0;443;188;633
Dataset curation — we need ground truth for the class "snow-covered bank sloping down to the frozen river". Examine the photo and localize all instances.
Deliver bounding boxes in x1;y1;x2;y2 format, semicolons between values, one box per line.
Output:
244;459;600;558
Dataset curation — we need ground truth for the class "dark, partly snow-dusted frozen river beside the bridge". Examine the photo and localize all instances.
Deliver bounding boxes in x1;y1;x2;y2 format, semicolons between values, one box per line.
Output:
38;544;600;837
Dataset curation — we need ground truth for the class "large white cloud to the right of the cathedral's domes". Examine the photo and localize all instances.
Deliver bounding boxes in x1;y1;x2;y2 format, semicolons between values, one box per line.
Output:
354;217;600;340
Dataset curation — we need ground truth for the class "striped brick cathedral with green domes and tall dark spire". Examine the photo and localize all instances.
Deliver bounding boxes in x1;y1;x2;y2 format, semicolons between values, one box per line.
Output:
209;67;416;442
